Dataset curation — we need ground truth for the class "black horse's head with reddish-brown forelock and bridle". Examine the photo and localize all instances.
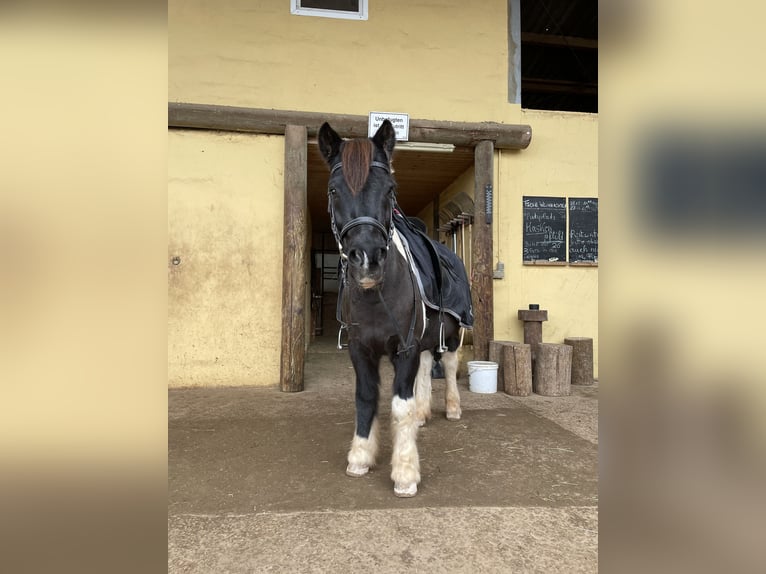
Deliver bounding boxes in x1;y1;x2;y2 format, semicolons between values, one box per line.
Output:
317;120;396;289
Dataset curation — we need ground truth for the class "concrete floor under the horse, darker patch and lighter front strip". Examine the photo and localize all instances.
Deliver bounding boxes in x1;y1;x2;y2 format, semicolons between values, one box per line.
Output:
168;338;598;573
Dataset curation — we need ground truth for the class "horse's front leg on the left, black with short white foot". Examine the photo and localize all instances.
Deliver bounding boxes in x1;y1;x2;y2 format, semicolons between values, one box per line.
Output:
346;345;380;477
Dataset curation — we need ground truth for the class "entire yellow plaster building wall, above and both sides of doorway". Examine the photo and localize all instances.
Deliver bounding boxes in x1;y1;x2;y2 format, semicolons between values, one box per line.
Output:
168;0;598;385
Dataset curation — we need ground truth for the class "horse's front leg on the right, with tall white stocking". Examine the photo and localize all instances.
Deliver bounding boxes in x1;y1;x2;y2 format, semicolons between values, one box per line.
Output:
391;354;420;497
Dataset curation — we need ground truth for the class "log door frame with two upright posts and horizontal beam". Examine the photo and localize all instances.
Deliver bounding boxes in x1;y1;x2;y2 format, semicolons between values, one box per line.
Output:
168;102;532;392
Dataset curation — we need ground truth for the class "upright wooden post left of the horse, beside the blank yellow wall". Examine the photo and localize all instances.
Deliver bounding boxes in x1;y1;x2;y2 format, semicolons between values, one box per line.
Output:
279;125;309;392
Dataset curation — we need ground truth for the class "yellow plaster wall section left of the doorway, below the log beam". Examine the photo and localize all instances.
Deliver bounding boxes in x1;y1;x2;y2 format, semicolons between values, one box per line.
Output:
168;130;284;386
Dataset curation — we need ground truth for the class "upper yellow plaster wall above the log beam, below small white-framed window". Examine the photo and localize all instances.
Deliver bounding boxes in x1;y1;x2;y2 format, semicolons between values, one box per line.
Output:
168;0;520;123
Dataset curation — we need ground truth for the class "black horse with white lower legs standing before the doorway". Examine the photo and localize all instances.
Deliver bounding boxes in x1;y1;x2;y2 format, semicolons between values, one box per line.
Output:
318;120;472;497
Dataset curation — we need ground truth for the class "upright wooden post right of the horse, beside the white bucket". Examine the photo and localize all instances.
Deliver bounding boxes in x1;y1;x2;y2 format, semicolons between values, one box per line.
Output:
471;141;495;361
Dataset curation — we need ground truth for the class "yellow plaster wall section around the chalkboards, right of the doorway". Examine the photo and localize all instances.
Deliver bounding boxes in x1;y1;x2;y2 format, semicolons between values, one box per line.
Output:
493;110;598;376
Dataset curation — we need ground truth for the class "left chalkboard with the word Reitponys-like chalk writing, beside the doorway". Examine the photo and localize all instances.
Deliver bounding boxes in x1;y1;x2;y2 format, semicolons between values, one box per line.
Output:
522;195;567;264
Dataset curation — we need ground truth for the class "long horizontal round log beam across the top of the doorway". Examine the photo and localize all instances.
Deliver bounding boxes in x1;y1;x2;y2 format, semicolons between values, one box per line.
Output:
168;102;532;149
